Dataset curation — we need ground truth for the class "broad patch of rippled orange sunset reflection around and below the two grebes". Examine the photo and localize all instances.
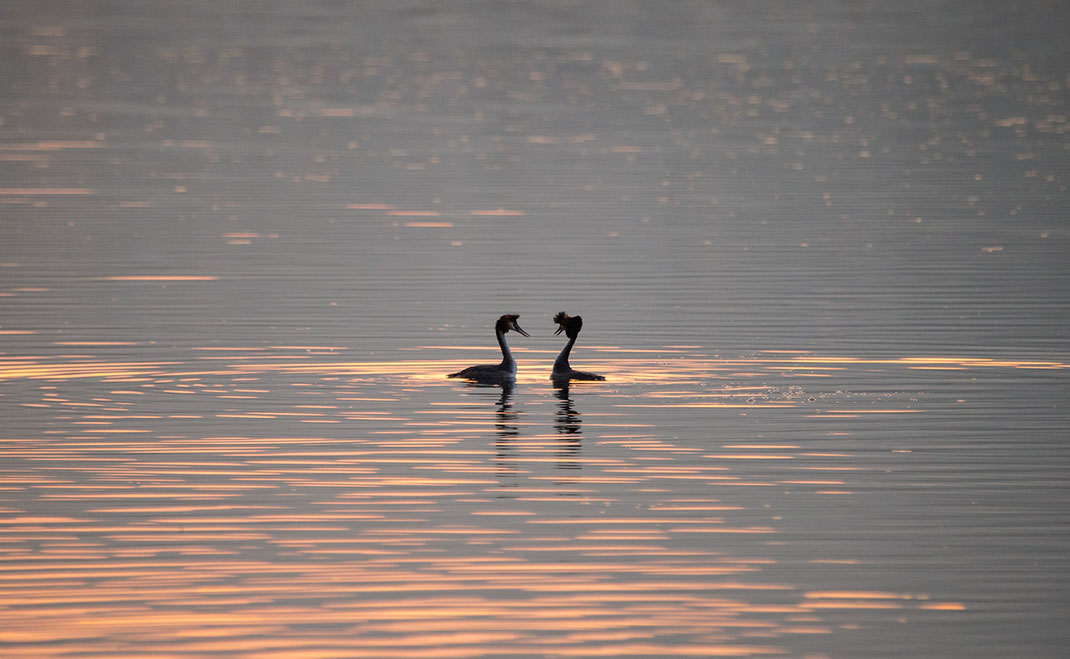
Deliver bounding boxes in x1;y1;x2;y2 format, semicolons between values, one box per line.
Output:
0;344;1014;658
